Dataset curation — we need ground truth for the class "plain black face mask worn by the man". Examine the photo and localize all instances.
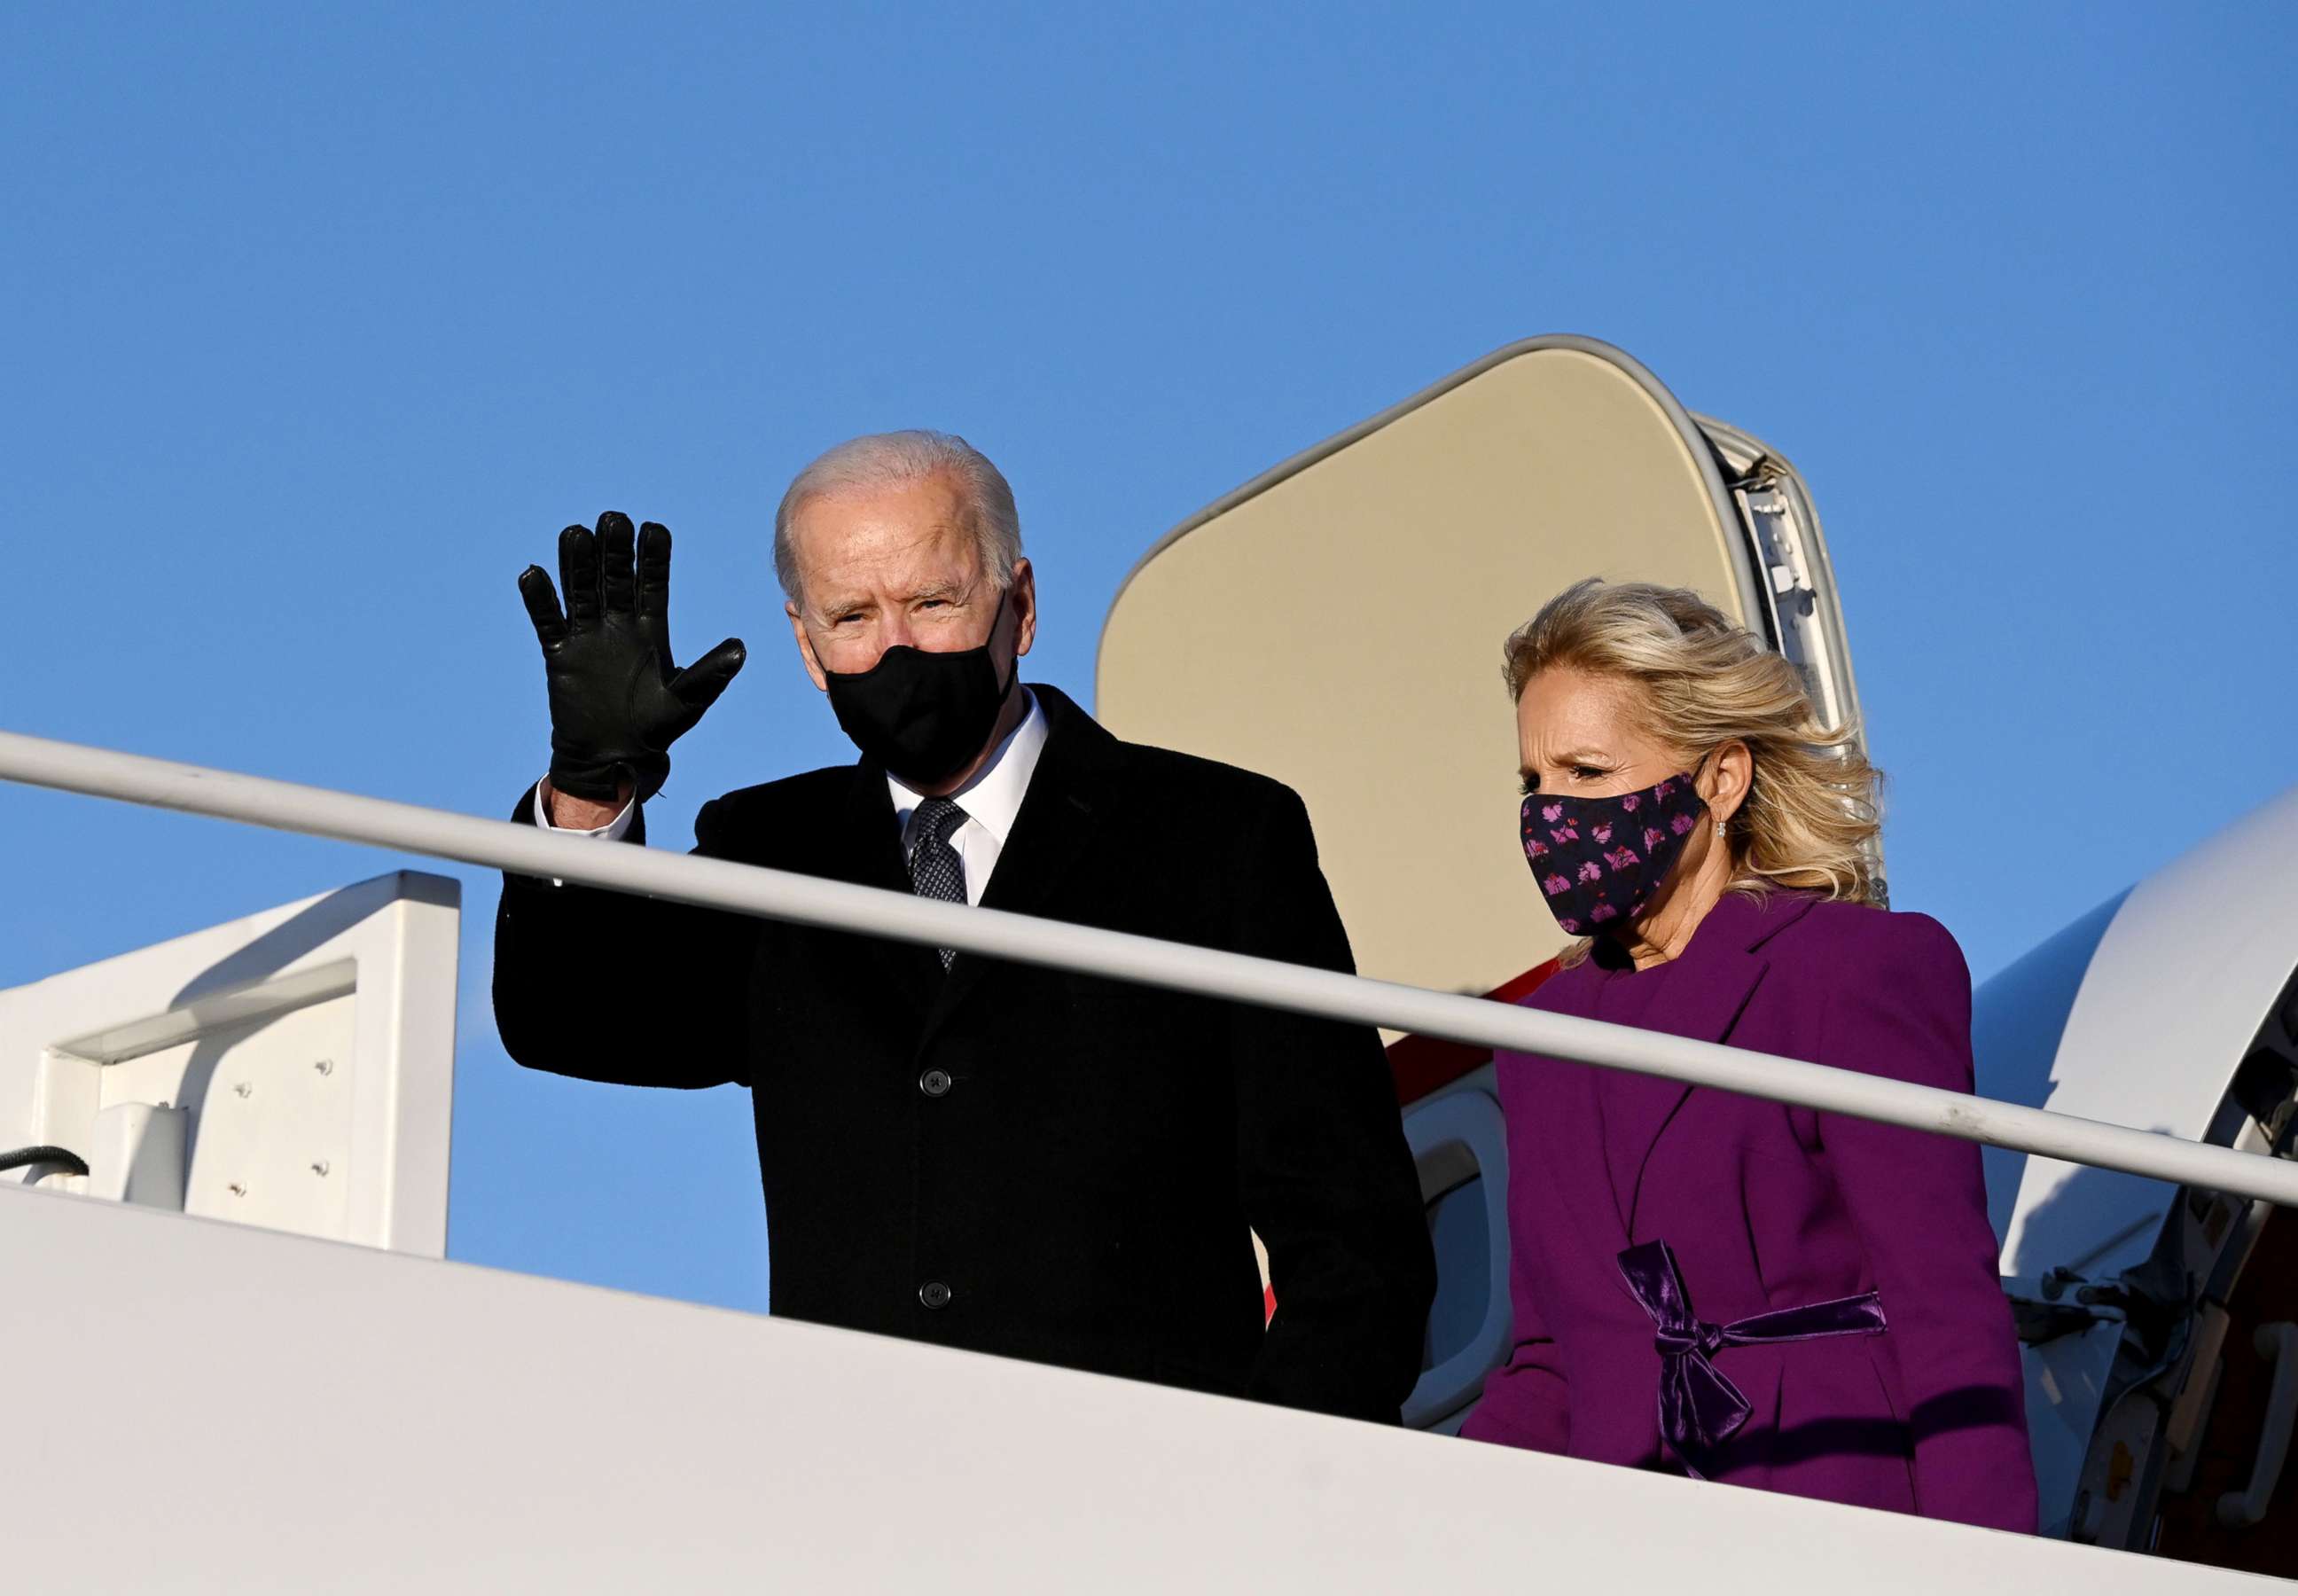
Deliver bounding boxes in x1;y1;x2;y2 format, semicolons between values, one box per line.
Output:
823;596;1020;786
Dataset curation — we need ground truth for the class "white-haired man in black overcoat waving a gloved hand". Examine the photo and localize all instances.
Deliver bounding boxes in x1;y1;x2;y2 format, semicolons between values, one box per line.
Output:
494;433;1434;1423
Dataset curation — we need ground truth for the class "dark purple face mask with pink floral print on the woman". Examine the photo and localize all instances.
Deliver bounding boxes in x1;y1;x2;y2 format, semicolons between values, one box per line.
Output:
1523;775;1708;936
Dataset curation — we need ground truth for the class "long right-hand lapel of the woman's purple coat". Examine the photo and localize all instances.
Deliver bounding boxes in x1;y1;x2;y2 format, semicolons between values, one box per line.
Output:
1597;895;1810;1240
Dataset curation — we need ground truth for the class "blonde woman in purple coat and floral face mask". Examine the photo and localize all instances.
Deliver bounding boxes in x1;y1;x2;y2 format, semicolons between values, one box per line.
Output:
1464;582;2036;1531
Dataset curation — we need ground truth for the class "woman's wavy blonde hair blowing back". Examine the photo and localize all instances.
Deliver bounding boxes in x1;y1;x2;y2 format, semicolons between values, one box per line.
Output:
1505;577;1884;906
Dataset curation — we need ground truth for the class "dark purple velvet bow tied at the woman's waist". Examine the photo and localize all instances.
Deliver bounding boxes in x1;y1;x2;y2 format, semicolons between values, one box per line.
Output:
1620;1242;1884;1479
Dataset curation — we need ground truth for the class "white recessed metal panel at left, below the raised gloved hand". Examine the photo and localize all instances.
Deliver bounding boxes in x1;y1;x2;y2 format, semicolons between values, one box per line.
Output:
0;872;459;1258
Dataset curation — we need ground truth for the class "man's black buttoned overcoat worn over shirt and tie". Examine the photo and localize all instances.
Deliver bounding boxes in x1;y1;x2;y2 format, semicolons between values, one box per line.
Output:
494;688;1434;1421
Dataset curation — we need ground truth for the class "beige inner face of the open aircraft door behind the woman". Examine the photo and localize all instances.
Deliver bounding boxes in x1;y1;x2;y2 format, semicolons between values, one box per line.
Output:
1096;338;1771;991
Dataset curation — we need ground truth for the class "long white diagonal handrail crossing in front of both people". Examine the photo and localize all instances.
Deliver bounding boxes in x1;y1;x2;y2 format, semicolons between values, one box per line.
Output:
0;732;2298;1208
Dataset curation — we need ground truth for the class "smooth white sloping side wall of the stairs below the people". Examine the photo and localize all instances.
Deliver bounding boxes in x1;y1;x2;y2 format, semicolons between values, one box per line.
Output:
0;1189;2271;1596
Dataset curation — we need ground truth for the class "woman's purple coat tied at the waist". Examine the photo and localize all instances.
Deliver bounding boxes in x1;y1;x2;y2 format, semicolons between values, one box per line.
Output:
1462;892;2036;1534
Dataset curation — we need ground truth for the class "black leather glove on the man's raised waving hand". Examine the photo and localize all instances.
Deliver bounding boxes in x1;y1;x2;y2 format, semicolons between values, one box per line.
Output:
520;511;745;802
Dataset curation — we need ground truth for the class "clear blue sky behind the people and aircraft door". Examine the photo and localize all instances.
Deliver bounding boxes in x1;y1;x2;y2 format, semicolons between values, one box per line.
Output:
0;4;2298;1306
